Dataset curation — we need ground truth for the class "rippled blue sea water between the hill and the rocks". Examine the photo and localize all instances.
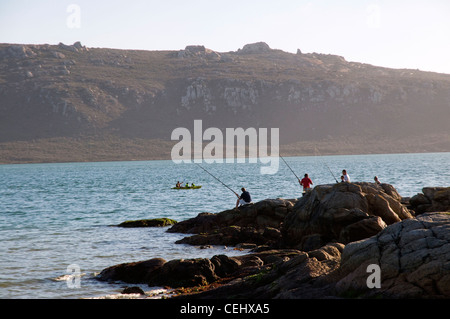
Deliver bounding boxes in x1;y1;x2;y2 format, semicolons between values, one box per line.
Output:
0;153;450;299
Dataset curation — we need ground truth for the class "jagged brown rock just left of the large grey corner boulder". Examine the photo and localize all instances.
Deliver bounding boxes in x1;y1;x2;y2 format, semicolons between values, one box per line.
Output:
178;243;343;299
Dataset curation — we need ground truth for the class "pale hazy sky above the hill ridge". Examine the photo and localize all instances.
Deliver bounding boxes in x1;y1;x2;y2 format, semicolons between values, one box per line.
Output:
0;0;450;74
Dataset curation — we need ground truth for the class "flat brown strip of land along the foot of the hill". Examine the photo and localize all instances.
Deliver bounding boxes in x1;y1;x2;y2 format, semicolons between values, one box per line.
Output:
0;134;450;164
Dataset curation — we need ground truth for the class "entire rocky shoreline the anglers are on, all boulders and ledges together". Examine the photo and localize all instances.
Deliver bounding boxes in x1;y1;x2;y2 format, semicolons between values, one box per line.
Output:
97;183;450;299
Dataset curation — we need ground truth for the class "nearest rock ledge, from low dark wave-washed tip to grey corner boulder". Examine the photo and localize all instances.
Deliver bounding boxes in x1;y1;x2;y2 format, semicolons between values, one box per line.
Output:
98;213;450;299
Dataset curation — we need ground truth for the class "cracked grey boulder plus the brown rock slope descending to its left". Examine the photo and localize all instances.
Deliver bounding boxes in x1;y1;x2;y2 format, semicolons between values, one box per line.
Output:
175;213;450;299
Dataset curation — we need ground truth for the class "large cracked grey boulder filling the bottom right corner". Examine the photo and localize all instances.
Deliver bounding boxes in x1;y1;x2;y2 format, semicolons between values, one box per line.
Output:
336;213;450;298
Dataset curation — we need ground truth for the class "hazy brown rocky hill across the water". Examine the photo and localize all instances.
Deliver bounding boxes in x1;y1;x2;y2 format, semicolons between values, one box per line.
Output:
0;42;450;163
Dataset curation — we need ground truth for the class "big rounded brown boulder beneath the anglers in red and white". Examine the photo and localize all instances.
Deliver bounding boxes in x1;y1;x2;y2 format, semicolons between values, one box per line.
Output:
282;183;413;251
